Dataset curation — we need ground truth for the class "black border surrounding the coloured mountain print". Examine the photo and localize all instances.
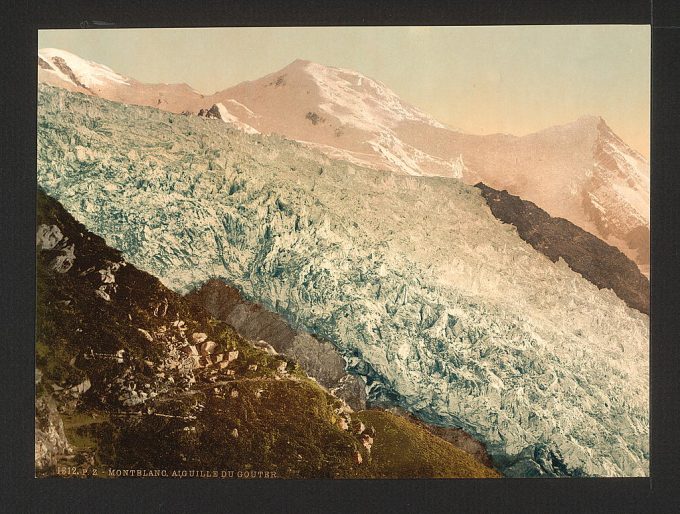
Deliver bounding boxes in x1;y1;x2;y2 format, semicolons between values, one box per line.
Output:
0;0;680;512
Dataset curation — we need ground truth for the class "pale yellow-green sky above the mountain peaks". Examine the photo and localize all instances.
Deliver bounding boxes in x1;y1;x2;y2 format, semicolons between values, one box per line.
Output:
38;25;651;157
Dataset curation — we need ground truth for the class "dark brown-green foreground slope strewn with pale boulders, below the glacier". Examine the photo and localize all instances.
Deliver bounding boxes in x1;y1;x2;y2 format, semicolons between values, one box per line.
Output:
36;192;498;478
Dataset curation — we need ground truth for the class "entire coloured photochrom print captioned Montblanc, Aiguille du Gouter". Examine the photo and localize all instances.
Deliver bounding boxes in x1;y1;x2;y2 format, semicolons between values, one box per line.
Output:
35;25;650;480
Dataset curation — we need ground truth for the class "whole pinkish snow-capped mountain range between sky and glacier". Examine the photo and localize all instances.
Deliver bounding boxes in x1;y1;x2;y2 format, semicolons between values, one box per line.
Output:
38;49;649;274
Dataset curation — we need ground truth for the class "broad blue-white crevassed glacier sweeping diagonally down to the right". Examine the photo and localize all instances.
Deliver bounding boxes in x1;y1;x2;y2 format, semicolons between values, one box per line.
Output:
37;86;649;476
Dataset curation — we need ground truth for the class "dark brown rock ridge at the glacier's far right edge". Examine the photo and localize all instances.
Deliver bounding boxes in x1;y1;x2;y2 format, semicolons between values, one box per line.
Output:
475;182;649;314
